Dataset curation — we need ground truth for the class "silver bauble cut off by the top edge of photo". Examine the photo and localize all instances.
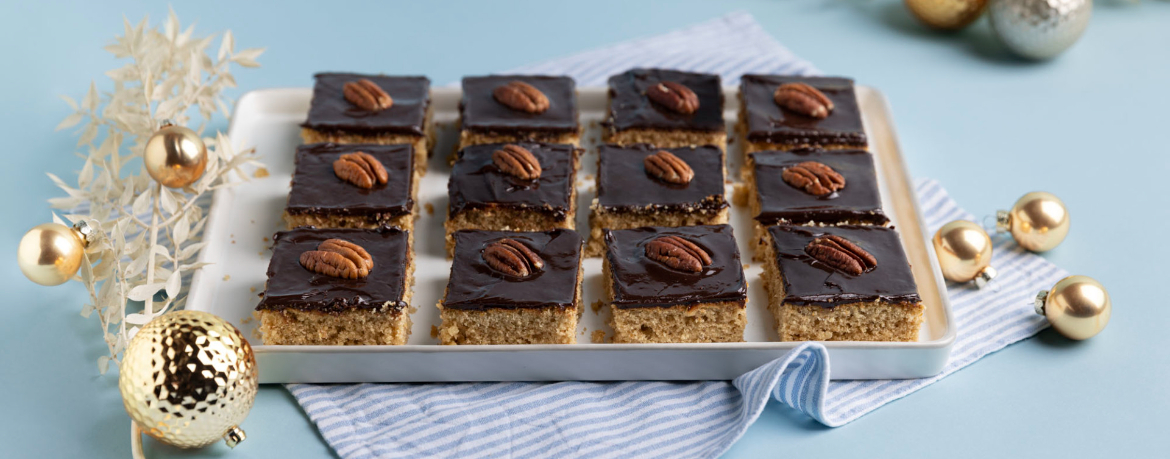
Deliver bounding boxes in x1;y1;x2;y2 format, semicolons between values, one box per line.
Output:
987;0;1093;60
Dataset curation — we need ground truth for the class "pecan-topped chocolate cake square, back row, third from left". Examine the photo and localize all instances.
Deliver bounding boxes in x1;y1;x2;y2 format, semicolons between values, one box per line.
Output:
604;68;727;150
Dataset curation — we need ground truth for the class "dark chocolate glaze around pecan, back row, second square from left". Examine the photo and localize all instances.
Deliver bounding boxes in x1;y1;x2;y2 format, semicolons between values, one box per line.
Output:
459;75;578;133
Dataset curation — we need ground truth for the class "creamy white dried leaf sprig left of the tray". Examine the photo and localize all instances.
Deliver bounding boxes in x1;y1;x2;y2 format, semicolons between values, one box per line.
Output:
49;11;263;374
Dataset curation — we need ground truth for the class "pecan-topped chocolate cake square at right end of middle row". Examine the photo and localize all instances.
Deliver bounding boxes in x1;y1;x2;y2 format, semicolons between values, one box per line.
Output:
746;149;889;254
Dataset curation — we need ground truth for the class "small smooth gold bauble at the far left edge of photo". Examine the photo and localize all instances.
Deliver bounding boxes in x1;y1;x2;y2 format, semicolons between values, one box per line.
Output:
16;222;89;286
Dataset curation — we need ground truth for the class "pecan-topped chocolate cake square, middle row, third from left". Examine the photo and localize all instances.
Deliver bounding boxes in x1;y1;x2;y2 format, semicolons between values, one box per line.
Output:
585;144;729;256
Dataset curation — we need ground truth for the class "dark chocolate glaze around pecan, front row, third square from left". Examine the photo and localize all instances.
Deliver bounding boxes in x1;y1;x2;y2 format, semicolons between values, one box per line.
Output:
605;225;748;308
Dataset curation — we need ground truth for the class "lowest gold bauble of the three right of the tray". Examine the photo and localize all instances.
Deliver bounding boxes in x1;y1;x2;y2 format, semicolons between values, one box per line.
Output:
1035;275;1113;340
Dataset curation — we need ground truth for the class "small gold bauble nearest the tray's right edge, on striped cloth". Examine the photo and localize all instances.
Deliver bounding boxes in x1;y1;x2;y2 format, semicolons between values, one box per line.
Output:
931;220;996;288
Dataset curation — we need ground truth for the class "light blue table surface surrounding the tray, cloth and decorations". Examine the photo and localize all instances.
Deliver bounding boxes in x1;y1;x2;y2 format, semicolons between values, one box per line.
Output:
0;0;1170;458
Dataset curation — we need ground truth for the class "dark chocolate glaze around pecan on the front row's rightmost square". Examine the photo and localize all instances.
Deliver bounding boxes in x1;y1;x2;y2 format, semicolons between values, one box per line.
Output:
768;225;922;306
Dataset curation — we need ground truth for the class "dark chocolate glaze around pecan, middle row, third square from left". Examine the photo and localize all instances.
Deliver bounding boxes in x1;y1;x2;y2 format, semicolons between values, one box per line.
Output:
598;144;728;211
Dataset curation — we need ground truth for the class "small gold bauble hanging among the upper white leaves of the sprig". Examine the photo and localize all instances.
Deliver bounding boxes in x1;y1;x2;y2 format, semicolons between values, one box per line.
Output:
143;124;207;189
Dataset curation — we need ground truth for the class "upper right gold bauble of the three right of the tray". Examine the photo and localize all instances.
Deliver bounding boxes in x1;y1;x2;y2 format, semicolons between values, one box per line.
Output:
996;191;1068;252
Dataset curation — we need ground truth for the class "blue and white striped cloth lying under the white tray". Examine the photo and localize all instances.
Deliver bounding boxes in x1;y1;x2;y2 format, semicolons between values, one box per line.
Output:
288;14;1066;458
